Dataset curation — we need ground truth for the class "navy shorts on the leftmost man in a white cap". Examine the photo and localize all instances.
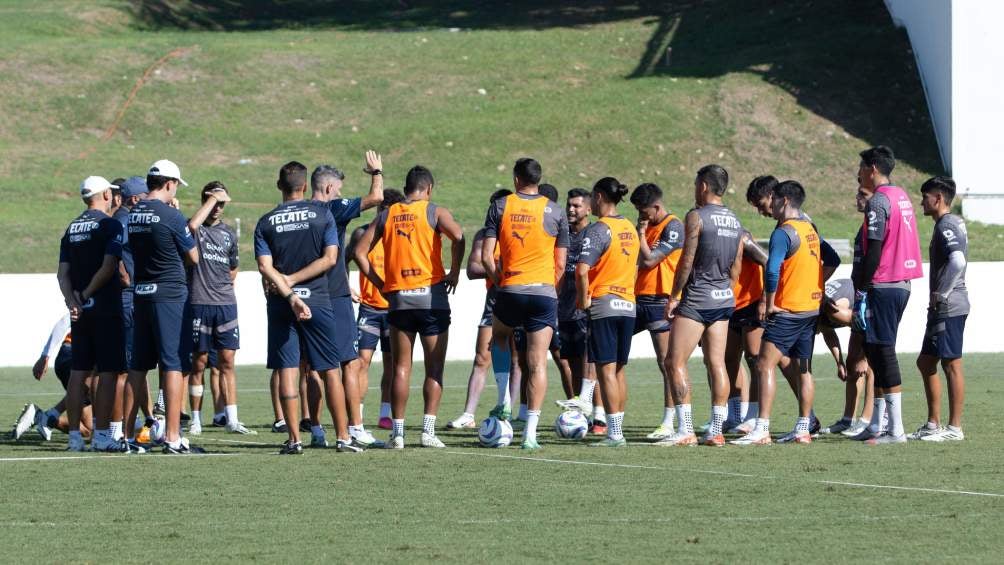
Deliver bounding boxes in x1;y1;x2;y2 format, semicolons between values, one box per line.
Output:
70;311;128;372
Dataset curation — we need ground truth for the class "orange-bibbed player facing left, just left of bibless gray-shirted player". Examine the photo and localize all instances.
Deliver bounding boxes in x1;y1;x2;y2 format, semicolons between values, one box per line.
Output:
631;183;684;440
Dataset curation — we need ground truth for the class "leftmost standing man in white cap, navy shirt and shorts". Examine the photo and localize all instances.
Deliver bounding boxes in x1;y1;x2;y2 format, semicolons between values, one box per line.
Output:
56;177;129;453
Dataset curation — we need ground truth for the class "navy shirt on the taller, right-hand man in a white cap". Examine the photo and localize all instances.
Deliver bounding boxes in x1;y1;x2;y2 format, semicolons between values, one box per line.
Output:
129;199;195;302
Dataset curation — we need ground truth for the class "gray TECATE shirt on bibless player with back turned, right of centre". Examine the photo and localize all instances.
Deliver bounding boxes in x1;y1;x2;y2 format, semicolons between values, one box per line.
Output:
681;204;743;310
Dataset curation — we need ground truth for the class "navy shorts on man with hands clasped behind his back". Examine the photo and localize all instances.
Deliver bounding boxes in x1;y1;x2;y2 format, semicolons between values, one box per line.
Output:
266;299;345;371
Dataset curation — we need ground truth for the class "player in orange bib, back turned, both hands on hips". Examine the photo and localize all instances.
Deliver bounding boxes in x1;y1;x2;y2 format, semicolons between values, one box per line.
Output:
355;165;464;450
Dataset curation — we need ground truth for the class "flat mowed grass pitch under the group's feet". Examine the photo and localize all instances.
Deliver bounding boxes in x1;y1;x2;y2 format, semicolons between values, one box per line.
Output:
0;354;1004;563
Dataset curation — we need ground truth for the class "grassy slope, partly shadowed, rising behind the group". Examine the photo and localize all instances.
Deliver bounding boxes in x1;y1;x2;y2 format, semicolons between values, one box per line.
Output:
0;0;1004;272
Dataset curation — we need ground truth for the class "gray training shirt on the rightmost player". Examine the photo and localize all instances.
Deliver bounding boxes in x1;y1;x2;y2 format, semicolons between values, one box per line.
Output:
929;214;969;318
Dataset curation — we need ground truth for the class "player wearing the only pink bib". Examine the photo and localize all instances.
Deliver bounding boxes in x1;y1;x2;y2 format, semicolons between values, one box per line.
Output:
852;146;924;444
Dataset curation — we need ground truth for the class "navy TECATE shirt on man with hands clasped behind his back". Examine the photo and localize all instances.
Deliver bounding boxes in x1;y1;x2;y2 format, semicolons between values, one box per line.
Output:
254;200;341;306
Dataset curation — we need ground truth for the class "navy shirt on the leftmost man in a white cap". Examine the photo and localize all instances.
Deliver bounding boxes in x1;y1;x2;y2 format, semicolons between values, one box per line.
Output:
59;210;122;316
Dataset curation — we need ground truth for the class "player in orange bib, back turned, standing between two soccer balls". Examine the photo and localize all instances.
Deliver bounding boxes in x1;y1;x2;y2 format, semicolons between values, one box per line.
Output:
482;158;568;450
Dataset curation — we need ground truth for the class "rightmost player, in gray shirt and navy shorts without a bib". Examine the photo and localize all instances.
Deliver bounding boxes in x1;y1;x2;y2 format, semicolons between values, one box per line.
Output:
912;177;969;442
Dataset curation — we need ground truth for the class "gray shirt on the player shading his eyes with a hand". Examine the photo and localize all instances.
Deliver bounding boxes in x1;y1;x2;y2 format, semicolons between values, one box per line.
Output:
189;222;238;305
